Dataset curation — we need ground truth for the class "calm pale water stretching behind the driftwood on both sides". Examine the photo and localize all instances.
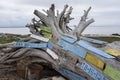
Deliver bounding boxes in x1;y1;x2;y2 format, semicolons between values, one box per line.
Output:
0;27;120;35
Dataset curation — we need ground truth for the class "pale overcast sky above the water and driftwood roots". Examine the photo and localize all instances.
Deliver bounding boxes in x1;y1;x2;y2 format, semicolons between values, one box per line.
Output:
0;0;120;27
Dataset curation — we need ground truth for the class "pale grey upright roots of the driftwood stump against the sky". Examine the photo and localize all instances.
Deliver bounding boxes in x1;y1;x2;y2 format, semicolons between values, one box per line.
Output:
33;4;94;40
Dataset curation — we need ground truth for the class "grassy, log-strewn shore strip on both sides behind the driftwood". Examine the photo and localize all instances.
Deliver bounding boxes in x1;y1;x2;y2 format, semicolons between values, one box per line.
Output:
0;33;120;44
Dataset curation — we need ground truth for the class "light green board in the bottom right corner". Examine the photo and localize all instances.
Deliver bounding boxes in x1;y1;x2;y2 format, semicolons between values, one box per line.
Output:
104;65;120;80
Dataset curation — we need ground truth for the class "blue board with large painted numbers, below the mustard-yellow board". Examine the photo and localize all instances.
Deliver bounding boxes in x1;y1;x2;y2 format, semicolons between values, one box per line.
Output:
80;62;109;80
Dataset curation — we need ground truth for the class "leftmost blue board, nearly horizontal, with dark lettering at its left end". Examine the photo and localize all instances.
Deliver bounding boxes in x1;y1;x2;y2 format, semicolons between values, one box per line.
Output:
14;42;47;48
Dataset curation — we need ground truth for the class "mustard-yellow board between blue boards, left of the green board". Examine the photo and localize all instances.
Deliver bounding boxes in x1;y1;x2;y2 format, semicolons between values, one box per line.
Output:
85;53;104;70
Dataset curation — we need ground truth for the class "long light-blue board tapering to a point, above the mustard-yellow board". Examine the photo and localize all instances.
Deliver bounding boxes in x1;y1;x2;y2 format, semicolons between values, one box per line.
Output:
77;40;115;58
